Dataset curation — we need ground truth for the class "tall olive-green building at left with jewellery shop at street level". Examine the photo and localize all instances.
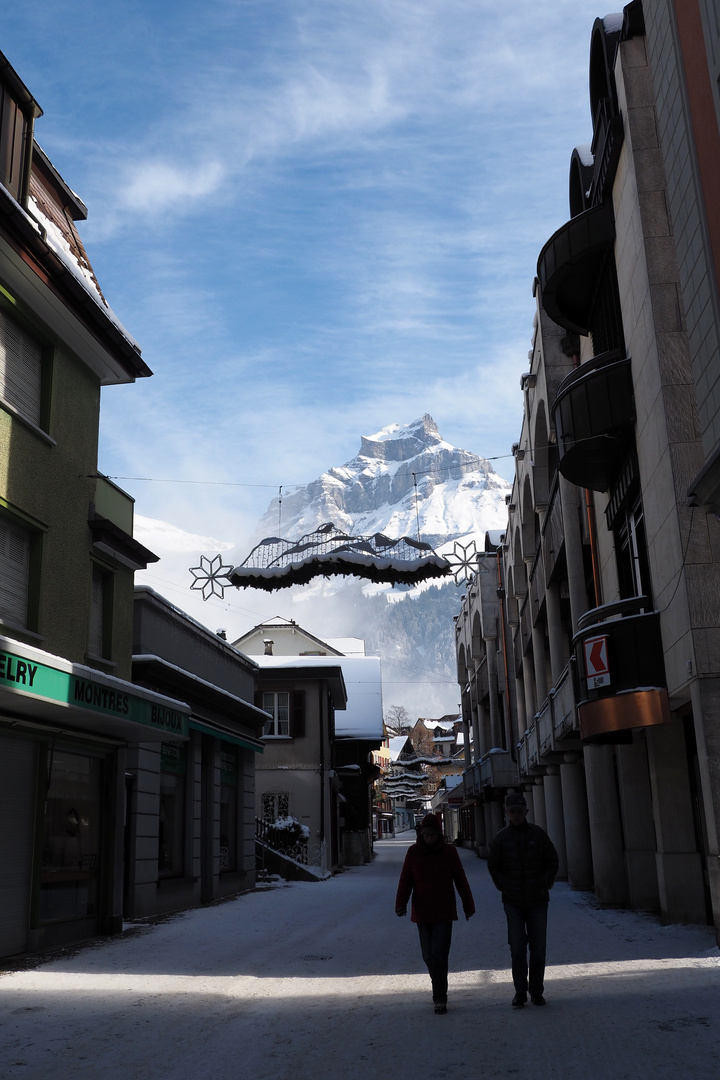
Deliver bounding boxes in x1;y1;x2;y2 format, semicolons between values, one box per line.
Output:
0;55;189;956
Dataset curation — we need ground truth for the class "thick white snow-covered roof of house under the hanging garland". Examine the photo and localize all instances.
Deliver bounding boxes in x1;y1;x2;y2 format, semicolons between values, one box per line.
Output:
254;657;384;740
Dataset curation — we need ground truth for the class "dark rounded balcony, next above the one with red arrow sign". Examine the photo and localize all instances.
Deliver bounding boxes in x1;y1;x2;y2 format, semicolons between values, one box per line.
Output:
553;351;635;491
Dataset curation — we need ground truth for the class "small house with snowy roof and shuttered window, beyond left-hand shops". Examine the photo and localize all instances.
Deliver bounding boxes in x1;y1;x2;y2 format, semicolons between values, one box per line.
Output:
233;618;383;868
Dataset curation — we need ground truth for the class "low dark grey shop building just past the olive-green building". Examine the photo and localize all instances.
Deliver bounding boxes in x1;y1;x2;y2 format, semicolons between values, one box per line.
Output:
125;586;267;918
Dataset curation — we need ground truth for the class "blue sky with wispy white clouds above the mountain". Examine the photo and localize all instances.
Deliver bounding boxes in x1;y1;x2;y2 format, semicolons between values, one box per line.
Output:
0;0;612;626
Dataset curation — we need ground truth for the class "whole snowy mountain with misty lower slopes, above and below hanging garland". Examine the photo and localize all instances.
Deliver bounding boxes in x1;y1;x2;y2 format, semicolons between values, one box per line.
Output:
248;414;511;716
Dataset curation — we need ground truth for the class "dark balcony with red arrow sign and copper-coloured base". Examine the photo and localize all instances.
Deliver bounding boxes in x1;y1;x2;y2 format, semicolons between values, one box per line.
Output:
573;596;670;743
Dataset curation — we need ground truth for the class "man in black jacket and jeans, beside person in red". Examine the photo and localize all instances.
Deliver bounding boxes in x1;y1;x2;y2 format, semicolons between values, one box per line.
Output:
488;792;558;1009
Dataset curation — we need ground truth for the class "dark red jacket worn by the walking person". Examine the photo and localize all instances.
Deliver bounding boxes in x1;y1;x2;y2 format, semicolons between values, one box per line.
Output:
395;839;475;922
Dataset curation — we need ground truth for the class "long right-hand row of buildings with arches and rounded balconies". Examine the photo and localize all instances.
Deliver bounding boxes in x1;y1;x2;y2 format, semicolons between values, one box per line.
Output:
456;0;720;931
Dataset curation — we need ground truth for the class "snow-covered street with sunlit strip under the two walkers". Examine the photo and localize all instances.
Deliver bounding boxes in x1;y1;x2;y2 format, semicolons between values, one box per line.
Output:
0;834;720;1080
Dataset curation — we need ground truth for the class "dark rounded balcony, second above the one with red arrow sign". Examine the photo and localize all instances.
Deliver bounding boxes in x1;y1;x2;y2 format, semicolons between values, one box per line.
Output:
538;203;615;335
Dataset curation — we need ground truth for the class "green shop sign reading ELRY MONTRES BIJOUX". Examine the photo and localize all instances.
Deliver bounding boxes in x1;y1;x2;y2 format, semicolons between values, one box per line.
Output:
0;652;189;735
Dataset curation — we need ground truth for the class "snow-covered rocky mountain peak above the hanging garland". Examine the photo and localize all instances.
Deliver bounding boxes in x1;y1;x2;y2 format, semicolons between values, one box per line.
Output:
256;414;510;551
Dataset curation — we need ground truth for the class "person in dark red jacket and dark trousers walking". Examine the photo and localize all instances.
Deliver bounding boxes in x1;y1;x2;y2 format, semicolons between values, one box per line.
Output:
395;813;475;1013
